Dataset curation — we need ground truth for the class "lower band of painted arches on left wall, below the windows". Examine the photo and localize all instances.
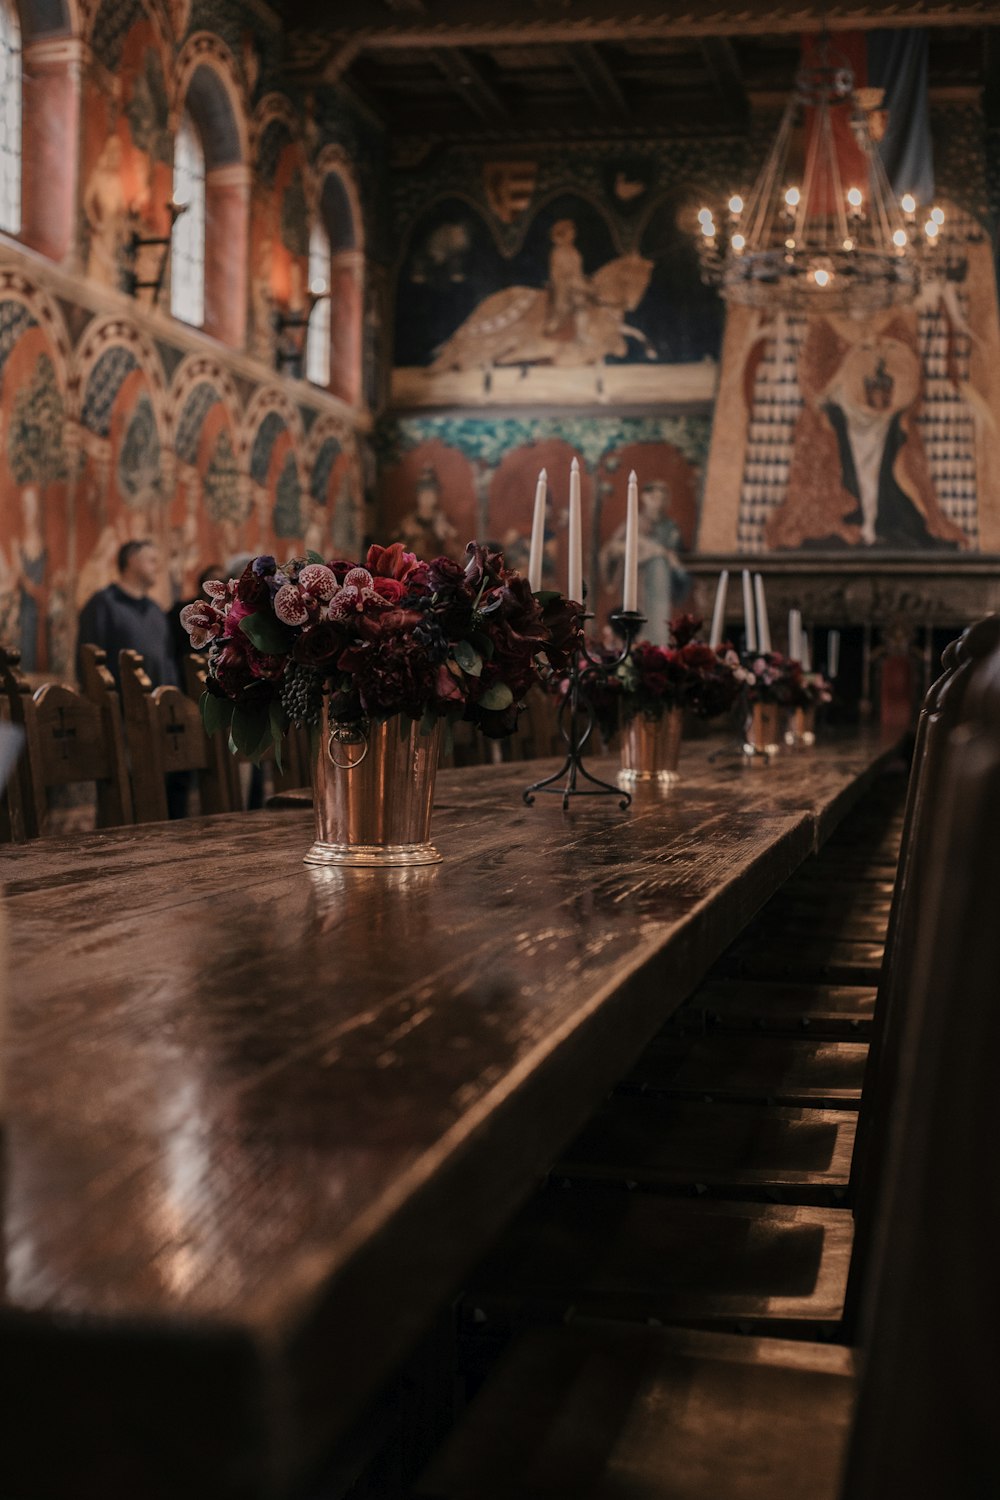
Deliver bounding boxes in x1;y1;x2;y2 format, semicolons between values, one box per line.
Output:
0;282;364;675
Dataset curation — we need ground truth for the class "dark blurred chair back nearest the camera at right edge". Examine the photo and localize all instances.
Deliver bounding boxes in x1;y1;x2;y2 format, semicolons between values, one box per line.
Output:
841;620;1000;1500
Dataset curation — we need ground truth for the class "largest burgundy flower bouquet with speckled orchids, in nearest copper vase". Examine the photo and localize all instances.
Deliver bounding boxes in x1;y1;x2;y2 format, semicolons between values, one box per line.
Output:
180;542;580;758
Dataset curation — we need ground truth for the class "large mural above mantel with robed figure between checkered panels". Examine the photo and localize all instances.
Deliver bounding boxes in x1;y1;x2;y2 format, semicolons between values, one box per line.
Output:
699;204;1000;554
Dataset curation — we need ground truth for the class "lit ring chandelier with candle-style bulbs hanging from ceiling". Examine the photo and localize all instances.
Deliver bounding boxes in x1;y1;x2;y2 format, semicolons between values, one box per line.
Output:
697;38;966;315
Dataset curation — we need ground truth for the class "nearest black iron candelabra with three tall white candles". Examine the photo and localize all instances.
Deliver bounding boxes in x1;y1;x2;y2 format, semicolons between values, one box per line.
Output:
523;459;646;812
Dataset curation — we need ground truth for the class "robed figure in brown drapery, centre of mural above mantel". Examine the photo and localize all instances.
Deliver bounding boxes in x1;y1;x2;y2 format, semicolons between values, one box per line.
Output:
765;317;967;551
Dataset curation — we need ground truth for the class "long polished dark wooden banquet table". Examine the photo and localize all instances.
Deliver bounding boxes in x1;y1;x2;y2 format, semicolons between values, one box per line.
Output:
0;740;891;1500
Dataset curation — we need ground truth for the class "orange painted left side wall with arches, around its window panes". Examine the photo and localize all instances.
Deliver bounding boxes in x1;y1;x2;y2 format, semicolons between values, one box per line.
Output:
0;0;379;678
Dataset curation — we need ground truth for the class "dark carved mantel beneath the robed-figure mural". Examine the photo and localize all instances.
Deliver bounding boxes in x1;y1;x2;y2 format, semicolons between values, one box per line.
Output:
685;552;1000;638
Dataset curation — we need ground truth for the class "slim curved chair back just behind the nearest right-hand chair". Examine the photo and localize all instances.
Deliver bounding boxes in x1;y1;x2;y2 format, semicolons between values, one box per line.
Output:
844;617;1000;1341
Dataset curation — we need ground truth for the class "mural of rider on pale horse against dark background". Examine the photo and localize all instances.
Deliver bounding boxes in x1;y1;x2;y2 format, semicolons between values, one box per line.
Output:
393;158;723;407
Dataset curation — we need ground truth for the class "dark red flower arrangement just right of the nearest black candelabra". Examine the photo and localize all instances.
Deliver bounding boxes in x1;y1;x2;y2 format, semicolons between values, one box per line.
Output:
588;615;741;737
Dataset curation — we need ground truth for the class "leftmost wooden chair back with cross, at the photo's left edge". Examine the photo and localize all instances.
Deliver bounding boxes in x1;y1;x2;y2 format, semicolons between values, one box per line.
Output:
0;648;132;839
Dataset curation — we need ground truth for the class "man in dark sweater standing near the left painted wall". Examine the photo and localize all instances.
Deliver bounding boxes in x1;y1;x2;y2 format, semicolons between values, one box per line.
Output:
76;539;180;687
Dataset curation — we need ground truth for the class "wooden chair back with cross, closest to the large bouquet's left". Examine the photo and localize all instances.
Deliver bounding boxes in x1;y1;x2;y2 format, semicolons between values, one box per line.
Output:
118;651;234;824
